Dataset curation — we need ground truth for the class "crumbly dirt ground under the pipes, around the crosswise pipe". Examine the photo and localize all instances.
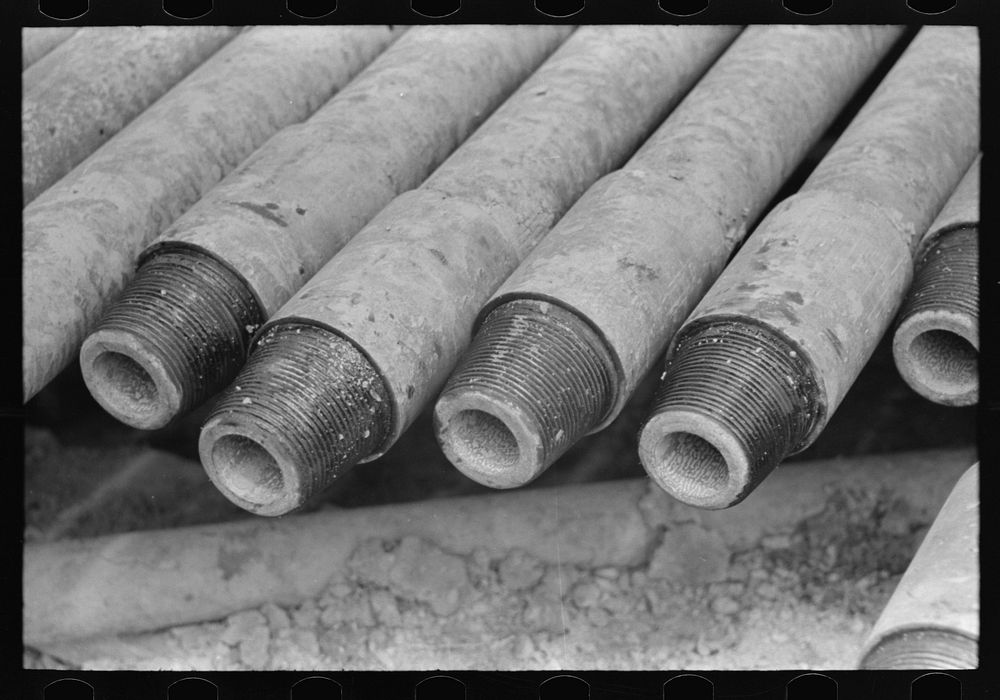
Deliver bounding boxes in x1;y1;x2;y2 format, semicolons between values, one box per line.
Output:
24;336;975;670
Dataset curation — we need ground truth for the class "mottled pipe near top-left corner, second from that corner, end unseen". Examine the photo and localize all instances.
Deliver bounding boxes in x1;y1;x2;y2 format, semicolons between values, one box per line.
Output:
21;27;238;204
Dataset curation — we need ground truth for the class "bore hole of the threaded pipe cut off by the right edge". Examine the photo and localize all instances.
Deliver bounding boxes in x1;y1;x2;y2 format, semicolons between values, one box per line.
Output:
910;329;979;394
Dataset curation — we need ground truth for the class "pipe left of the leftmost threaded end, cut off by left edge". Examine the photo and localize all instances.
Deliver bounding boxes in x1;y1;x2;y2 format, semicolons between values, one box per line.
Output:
23;27;400;401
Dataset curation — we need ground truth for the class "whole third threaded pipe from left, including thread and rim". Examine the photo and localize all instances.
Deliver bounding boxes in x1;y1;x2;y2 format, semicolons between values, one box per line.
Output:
435;26;902;487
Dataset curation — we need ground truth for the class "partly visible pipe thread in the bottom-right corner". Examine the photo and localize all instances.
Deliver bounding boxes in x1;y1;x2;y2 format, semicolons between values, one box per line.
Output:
860;627;979;671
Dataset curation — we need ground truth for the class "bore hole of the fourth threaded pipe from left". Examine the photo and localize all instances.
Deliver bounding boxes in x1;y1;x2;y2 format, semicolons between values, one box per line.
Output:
653;433;729;498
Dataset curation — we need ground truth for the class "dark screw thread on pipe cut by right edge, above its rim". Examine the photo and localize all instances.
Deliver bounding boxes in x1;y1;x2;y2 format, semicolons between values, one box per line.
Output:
899;228;979;323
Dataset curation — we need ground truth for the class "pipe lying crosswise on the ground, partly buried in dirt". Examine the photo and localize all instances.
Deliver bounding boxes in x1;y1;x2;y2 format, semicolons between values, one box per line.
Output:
22;450;975;646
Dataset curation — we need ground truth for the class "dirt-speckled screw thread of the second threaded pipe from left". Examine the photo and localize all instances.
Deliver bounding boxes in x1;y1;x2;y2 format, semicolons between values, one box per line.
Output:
206;322;391;508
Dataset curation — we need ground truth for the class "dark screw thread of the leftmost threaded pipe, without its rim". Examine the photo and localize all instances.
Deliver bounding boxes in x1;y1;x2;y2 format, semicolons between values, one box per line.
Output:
89;248;264;422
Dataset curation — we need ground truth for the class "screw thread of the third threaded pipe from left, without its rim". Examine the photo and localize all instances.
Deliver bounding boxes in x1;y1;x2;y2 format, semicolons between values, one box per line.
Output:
442;299;615;476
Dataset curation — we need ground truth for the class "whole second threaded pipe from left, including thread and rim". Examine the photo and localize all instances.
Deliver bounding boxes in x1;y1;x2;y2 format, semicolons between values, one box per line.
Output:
199;26;738;515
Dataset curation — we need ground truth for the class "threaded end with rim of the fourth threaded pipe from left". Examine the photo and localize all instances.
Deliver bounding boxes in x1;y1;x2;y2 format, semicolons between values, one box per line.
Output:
639;318;823;508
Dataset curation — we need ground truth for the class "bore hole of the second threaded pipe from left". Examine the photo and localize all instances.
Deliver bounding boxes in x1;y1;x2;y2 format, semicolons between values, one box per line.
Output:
212;435;285;505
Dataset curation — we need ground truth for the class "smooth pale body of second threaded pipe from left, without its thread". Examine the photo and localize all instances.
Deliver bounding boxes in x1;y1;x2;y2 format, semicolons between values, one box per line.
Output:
200;26;738;516
